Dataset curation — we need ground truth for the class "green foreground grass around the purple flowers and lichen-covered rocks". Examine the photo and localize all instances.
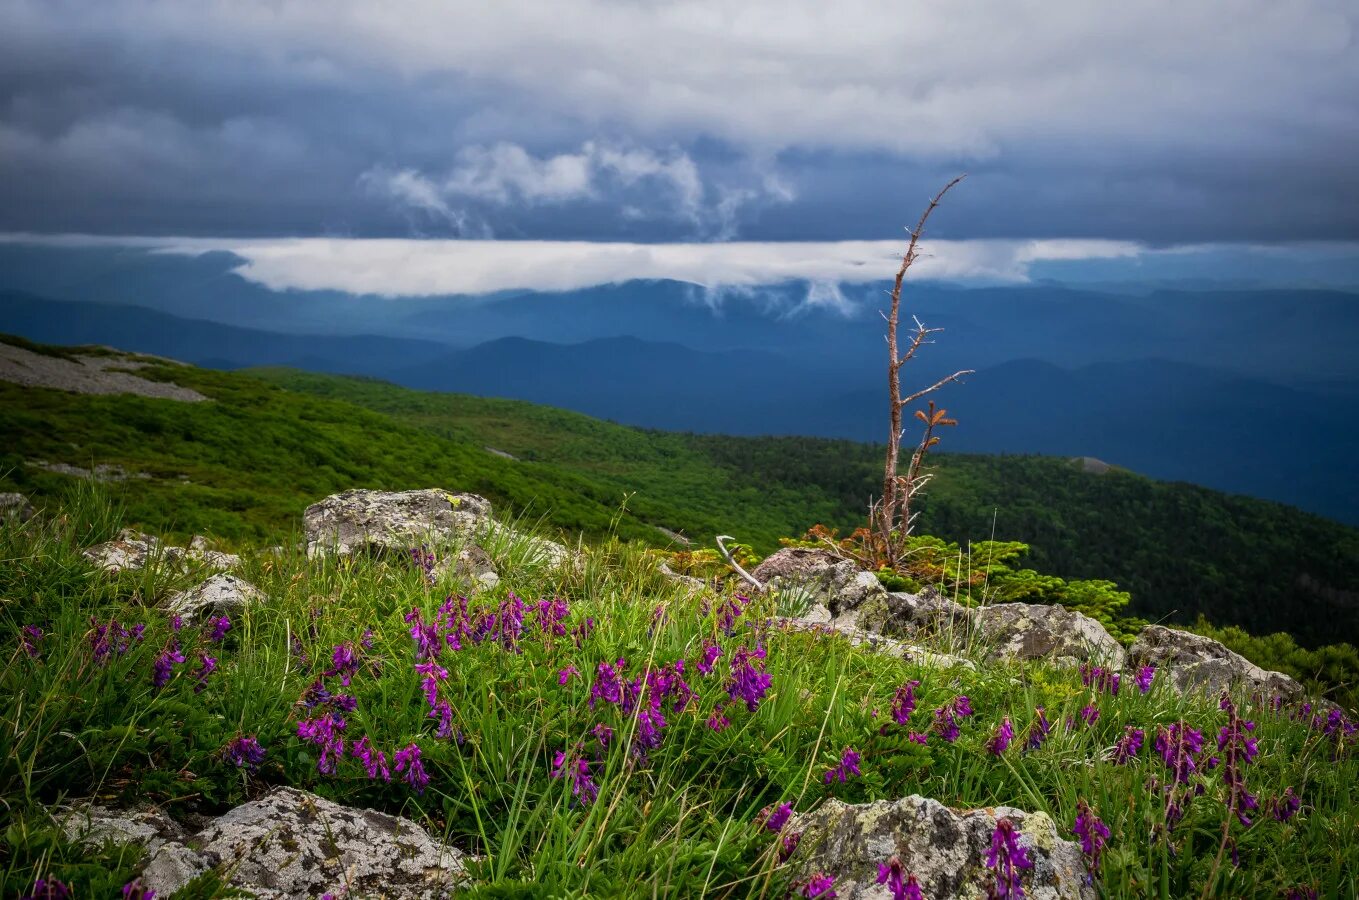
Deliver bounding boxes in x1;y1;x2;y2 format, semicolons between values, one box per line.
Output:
0;488;1359;897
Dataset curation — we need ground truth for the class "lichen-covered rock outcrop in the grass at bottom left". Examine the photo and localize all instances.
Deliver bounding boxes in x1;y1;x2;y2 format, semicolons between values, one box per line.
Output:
64;787;465;900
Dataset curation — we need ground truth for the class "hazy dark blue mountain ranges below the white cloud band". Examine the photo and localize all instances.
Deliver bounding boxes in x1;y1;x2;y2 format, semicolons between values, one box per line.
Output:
0;243;1359;523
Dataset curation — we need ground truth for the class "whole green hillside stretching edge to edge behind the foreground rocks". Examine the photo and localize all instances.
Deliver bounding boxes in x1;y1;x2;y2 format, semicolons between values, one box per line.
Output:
0;343;1359;646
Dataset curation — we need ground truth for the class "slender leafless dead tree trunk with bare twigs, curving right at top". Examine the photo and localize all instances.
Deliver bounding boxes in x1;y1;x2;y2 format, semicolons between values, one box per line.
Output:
870;175;972;566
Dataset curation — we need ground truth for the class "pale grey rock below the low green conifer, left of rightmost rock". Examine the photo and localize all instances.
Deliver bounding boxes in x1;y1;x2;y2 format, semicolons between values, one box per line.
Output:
972;604;1128;669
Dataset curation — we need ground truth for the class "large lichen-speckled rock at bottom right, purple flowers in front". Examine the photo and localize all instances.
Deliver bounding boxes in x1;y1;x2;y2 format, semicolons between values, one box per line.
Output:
784;795;1097;900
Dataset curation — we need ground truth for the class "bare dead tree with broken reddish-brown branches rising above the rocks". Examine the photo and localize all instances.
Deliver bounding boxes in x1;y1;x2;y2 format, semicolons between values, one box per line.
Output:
870;175;972;567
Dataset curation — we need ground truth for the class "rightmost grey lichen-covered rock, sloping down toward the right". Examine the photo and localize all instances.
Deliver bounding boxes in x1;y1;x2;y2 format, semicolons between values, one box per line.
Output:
1128;625;1303;702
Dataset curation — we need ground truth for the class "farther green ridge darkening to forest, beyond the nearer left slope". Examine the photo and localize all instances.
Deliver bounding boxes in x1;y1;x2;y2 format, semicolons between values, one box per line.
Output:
247;370;1359;643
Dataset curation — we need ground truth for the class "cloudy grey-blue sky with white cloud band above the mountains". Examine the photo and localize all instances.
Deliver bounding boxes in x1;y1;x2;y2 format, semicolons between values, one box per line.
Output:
0;0;1359;290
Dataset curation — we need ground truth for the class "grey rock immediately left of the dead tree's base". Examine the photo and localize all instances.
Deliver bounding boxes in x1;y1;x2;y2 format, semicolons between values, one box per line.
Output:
750;547;887;631
